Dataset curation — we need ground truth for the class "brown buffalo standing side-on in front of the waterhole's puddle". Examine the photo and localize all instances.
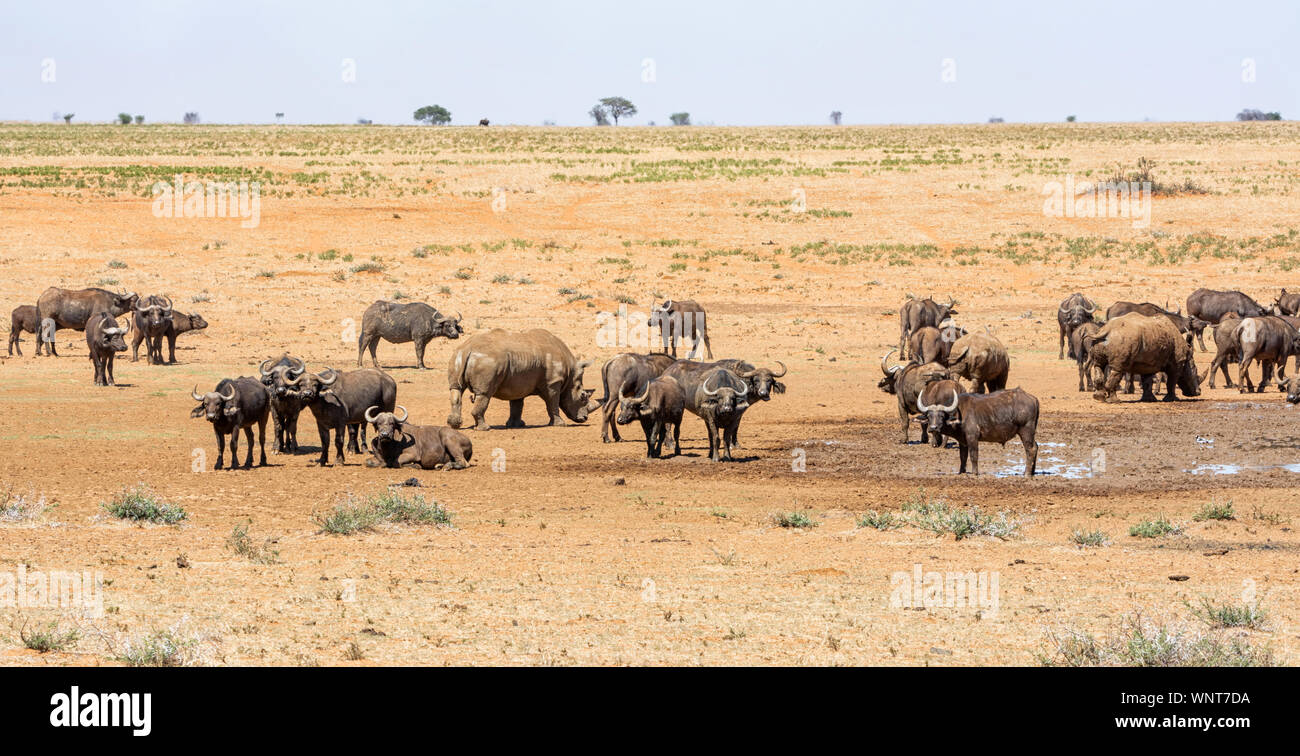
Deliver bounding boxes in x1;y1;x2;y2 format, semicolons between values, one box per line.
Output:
918;388;1039;478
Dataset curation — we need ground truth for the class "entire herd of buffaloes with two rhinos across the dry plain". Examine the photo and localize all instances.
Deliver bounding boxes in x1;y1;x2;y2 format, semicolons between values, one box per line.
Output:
9;287;1300;475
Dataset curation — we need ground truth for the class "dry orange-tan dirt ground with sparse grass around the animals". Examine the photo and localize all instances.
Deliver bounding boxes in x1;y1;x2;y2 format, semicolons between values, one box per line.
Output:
0;123;1300;665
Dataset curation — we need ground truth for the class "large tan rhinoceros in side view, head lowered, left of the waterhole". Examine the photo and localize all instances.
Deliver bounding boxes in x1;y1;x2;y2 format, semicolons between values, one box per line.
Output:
447;329;597;430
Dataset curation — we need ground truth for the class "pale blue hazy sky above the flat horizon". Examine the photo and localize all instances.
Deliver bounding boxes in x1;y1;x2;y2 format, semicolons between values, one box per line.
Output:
0;0;1300;125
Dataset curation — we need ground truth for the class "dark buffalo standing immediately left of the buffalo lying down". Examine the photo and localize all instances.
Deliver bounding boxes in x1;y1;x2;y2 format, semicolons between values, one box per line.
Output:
287;368;398;466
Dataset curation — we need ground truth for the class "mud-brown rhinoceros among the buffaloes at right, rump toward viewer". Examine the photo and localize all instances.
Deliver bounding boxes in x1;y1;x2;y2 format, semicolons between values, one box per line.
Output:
1088;313;1200;401
